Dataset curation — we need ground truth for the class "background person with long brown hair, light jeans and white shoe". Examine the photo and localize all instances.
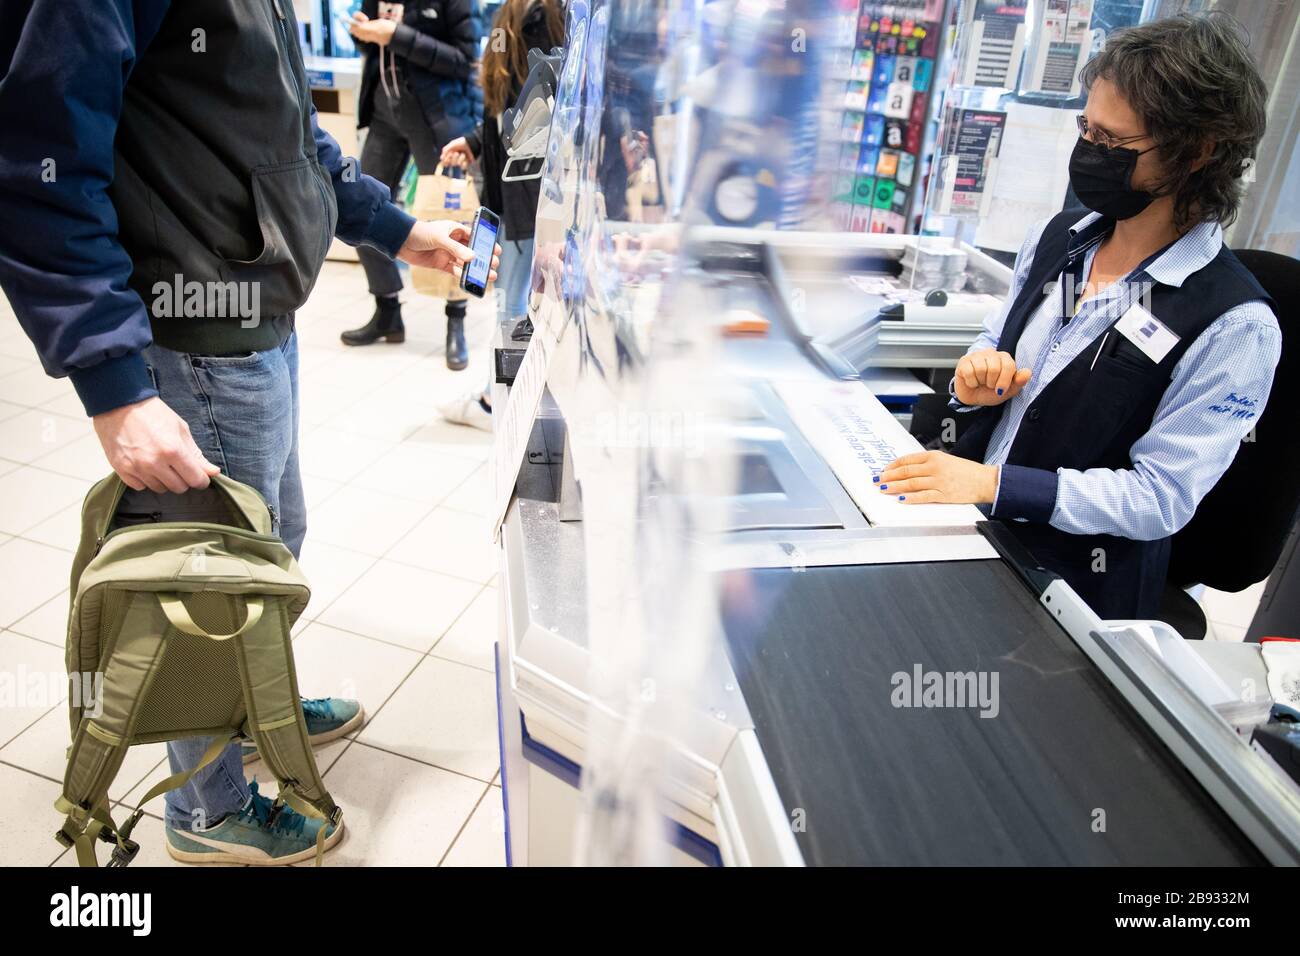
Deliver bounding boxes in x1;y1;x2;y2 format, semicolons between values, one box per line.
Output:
441;0;564;431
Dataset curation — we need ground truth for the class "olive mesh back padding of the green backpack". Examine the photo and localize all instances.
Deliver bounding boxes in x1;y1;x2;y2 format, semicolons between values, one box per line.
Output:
135;591;244;735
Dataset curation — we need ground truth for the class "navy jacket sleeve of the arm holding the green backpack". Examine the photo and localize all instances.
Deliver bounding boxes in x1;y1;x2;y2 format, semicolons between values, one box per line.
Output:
0;0;168;415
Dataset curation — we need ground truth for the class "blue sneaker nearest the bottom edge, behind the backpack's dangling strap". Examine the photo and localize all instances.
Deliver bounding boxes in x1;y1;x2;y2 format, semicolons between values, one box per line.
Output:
166;780;343;866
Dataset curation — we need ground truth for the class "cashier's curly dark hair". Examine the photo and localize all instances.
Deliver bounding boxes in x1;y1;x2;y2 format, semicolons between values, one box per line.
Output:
1080;12;1268;232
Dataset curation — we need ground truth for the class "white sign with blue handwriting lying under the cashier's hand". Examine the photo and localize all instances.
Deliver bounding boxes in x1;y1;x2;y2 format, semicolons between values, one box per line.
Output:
775;381;984;528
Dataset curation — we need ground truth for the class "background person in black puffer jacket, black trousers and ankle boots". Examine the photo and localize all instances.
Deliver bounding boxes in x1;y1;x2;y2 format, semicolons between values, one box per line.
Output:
342;0;478;369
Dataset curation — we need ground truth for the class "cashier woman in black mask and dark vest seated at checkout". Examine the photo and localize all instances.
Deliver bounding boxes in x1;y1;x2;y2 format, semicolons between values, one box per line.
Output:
876;14;1282;619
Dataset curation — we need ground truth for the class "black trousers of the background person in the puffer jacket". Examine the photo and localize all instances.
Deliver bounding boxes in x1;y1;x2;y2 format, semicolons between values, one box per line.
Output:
356;88;467;316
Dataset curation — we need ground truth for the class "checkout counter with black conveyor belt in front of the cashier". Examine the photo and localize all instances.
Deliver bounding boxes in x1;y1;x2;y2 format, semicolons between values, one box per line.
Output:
494;229;1300;866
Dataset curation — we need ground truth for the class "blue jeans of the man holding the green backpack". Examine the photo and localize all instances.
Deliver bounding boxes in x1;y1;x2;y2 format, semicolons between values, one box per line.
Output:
131;336;307;830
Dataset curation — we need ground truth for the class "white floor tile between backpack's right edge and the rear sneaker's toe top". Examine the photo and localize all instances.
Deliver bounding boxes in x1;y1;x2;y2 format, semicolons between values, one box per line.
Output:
294;622;420;719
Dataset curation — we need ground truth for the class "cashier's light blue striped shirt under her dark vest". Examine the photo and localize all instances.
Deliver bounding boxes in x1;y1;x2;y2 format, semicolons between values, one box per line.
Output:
953;213;1282;541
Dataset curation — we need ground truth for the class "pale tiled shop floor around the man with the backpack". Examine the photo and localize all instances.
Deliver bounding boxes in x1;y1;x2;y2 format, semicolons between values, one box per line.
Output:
0;263;504;866
